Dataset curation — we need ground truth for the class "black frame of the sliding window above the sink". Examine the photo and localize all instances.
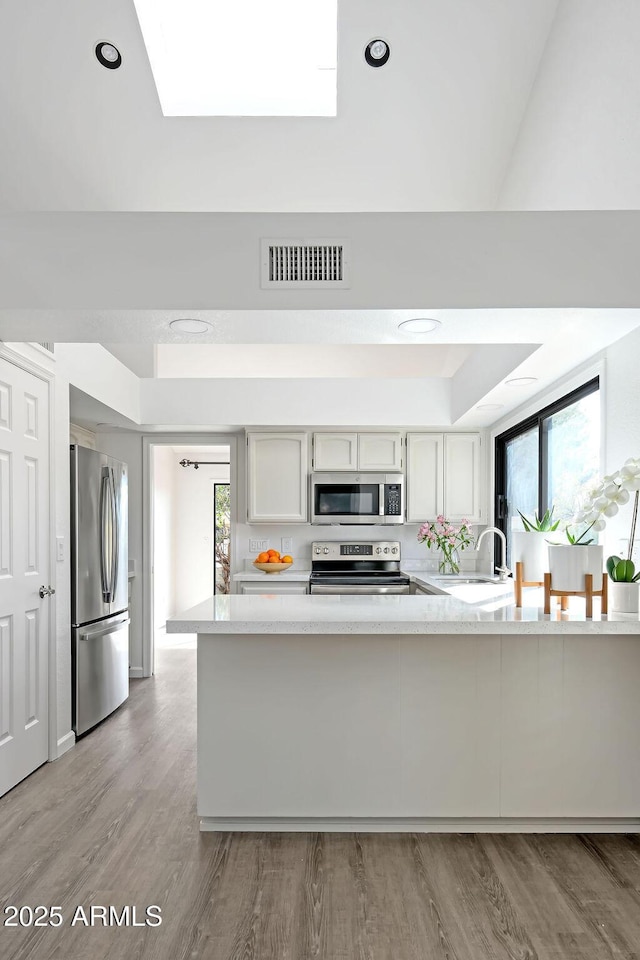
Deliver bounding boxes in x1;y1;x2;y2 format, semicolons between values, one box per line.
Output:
493;374;601;537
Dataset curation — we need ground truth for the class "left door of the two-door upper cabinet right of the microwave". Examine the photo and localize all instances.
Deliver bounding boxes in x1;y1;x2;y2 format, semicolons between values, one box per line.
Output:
407;433;444;523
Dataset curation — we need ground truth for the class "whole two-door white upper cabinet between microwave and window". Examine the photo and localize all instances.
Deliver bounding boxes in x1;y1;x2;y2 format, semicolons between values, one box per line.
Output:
407;433;486;523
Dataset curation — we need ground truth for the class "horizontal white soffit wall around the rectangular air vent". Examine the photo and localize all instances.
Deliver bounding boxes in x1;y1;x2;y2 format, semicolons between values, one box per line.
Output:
0;214;640;316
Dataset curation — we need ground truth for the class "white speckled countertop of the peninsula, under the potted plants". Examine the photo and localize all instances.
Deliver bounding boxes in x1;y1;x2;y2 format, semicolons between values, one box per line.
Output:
167;588;640;635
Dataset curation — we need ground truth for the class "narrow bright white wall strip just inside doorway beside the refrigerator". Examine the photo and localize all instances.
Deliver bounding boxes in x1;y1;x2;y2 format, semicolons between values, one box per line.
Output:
153;445;178;630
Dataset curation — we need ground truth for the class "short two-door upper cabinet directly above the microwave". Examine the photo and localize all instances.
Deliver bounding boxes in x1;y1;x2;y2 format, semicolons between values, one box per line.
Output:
313;433;402;473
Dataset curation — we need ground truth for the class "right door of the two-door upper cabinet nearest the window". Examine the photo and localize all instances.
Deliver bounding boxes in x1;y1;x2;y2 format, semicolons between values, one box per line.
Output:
444;433;485;523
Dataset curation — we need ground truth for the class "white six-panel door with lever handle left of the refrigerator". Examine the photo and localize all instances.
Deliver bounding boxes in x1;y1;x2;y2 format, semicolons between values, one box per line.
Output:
0;360;51;795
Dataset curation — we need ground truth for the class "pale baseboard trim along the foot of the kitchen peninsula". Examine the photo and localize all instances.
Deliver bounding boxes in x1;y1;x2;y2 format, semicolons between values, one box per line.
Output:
200;817;640;833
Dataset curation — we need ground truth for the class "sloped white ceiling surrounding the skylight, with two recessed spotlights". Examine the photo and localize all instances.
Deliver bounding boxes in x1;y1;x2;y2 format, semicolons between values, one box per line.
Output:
0;0;558;211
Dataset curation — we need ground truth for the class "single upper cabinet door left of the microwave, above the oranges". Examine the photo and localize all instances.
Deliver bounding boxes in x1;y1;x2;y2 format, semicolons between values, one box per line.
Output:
247;433;308;523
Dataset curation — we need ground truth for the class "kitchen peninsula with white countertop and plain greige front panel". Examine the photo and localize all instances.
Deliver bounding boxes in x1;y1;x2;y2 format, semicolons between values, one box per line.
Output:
167;595;640;832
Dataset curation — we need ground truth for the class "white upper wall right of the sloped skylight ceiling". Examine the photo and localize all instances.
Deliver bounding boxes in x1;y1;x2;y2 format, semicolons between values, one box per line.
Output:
498;0;640;210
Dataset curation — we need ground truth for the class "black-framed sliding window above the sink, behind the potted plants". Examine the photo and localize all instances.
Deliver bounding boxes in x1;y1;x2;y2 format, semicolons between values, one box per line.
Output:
495;378;600;565
